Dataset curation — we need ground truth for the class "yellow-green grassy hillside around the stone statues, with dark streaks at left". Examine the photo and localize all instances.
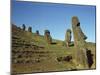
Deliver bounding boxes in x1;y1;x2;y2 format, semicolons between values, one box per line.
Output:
11;25;95;73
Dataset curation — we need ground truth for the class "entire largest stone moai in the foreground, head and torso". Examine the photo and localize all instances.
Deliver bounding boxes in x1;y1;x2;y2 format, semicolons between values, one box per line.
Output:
72;16;88;69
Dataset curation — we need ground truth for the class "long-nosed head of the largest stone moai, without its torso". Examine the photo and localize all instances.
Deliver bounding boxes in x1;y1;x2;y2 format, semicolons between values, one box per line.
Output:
72;16;87;47
